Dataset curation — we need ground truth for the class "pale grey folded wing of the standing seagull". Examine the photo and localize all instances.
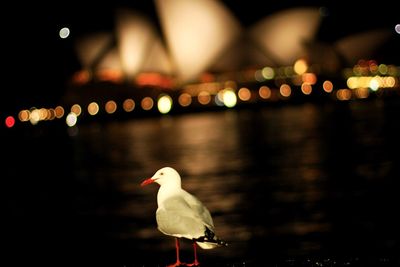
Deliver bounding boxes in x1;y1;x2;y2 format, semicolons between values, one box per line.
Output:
156;193;214;239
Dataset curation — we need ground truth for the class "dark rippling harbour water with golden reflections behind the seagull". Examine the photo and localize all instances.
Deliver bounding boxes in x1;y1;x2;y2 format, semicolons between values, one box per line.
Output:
3;99;400;266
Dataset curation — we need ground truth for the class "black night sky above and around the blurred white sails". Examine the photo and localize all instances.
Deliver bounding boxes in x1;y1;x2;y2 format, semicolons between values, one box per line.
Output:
0;0;400;111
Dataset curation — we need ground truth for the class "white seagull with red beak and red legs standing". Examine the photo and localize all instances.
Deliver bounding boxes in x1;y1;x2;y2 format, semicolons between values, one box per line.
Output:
141;167;228;267
